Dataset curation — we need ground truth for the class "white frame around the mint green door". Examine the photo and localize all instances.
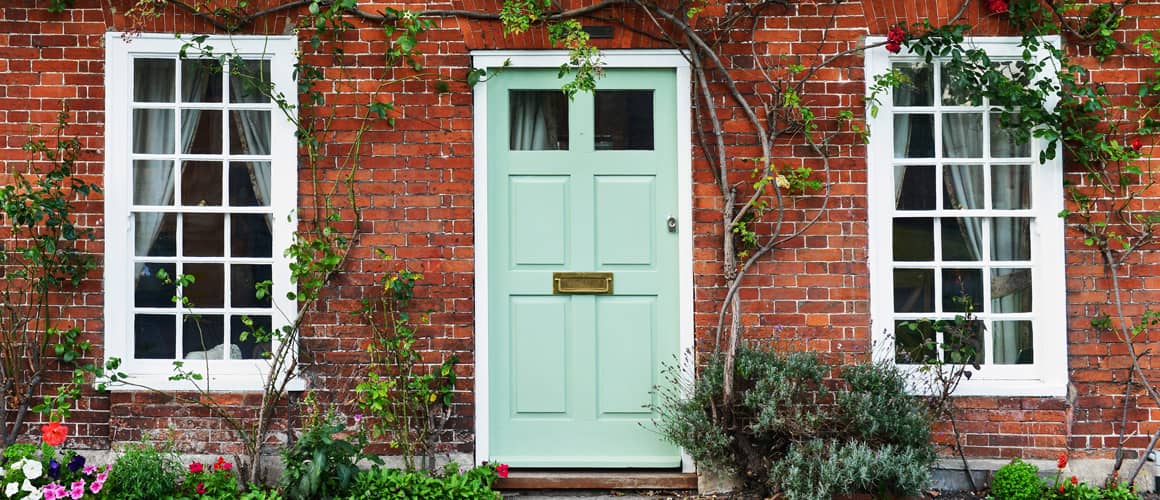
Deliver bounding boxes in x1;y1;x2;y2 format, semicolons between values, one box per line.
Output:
471;50;694;472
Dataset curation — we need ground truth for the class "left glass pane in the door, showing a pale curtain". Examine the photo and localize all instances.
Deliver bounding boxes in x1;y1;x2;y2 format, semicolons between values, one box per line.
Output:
508;90;568;151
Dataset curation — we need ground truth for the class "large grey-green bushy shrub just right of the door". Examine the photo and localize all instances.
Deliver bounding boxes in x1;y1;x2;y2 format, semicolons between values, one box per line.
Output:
657;347;935;499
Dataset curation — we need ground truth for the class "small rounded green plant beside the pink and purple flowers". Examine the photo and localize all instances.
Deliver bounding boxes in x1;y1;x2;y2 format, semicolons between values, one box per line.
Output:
103;442;182;500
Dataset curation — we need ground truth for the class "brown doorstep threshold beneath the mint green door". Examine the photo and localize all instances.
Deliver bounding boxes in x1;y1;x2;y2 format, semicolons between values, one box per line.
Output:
494;470;697;490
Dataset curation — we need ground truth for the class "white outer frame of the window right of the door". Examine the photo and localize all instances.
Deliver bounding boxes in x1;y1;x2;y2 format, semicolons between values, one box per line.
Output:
865;37;1067;397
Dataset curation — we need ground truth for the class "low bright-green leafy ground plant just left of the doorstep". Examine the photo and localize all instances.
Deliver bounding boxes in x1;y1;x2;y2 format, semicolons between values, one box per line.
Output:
347;463;500;500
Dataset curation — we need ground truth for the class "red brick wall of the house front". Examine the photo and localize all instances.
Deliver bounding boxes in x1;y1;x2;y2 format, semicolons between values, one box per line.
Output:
0;0;1160;466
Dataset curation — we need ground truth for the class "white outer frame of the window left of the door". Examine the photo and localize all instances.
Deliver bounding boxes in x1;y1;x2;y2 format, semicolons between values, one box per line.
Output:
104;32;303;392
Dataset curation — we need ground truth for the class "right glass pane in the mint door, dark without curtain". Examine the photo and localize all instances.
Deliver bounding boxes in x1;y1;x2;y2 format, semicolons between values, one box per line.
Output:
594;90;653;151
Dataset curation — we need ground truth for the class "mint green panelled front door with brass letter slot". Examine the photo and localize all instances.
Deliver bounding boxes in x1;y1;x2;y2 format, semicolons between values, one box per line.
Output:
486;68;680;468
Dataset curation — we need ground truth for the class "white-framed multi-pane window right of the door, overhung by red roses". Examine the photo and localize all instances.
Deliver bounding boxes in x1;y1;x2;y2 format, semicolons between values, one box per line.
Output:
867;35;1066;396
